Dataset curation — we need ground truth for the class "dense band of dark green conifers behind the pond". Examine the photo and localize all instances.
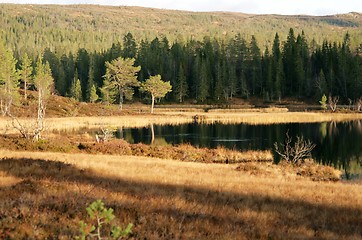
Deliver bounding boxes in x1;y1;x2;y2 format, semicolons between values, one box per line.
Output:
4;29;362;103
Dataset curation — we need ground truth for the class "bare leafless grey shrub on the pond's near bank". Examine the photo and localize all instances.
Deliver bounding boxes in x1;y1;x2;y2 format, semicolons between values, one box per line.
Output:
274;132;316;164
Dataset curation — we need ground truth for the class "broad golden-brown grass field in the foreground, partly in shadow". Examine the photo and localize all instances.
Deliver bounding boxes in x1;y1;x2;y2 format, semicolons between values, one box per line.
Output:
0;150;362;239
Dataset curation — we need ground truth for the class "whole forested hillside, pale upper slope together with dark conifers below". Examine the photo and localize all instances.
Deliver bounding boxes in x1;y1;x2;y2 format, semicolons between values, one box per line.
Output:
0;5;362;103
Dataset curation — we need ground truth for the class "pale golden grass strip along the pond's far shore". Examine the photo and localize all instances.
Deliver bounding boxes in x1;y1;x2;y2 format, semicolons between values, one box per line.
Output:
0;111;362;133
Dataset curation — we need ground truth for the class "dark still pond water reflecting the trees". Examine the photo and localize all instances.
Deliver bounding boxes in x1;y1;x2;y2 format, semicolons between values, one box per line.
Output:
116;120;362;179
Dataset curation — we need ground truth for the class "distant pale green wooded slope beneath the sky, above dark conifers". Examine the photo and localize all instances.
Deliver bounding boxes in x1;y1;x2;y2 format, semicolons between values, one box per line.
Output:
0;4;362;54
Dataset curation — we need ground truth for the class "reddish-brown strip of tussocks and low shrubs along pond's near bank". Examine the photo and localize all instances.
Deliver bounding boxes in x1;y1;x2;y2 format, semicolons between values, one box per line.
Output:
0;136;273;163
